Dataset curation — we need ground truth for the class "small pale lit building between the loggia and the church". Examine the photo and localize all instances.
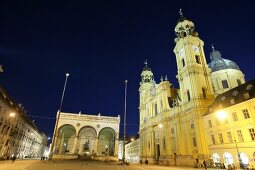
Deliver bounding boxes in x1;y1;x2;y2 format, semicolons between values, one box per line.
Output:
125;139;140;163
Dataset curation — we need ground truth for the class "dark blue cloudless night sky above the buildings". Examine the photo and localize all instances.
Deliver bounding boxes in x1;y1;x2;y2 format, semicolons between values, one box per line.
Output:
0;0;255;140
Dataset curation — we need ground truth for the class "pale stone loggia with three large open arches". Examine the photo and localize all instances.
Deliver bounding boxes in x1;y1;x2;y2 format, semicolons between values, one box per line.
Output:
52;112;120;159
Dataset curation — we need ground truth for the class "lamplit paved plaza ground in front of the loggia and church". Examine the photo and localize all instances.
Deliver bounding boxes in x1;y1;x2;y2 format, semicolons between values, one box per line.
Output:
0;160;217;170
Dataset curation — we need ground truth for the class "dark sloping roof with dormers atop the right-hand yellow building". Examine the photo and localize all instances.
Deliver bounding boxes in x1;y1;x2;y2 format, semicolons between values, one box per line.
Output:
209;79;255;113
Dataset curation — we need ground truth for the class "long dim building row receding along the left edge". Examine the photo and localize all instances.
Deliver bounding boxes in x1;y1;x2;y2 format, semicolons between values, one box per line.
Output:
0;87;47;158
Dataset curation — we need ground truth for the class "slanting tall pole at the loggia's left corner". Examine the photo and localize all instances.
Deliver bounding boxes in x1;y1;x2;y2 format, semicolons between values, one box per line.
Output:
49;73;70;159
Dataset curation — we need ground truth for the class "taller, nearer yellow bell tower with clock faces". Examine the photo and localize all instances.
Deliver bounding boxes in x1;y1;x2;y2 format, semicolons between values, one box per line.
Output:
173;10;213;103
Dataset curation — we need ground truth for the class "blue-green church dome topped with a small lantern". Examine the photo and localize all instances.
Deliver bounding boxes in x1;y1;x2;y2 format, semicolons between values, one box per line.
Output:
208;47;240;72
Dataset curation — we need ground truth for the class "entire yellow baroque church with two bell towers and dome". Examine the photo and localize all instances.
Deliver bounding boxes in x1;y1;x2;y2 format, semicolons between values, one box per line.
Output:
139;13;255;166
